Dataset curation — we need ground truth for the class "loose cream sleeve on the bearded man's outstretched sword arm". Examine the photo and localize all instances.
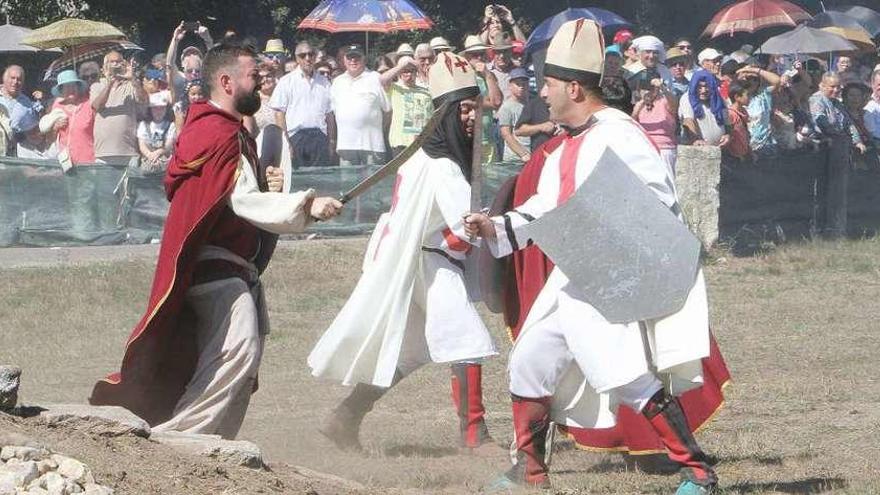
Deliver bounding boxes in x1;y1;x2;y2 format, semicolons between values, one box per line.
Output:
229;157;315;234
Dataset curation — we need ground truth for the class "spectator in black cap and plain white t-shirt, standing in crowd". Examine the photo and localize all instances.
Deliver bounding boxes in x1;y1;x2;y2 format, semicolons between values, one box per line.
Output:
330;45;391;166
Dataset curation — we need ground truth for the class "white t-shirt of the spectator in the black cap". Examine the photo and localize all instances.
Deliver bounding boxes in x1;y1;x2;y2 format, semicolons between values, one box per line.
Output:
330;70;391;153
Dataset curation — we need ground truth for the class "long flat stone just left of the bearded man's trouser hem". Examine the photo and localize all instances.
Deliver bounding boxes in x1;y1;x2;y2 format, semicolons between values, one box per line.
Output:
40;404;150;438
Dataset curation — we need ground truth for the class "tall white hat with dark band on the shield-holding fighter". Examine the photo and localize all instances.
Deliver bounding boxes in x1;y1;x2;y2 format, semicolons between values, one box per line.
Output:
544;19;605;81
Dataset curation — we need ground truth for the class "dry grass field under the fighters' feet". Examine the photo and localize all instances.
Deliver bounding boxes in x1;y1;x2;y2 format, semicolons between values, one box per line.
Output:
0;239;880;494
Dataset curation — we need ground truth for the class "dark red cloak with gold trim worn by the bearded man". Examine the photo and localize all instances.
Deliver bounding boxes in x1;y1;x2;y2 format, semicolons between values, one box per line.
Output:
89;102;256;425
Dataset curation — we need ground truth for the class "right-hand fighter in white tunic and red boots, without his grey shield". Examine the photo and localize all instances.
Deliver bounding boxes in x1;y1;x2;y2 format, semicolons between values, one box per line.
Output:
466;19;717;495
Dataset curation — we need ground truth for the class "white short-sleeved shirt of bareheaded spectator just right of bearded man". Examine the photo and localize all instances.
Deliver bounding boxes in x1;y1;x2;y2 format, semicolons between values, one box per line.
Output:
269;67;331;136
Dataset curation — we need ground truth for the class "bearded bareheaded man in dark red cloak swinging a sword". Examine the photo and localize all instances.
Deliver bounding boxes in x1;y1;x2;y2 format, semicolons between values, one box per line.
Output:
90;40;342;438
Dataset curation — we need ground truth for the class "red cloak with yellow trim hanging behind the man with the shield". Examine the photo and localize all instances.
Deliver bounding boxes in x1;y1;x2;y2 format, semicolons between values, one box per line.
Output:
493;136;730;454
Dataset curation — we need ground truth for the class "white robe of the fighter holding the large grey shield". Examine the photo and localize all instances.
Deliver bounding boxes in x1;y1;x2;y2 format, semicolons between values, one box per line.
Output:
488;109;709;428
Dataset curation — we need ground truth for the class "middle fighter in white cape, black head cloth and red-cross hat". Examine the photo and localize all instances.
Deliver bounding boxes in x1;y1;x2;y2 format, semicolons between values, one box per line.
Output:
308;52;496;456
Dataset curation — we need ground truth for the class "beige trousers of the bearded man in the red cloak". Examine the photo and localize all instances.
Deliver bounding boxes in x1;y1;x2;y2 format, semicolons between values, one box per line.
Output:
153;278;268;439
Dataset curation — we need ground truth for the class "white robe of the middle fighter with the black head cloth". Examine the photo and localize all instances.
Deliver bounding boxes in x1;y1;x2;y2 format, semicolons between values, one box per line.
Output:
308;150;497;387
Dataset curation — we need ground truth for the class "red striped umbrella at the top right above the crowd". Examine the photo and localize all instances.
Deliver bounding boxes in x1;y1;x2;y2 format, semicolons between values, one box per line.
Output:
702;0;813;38
